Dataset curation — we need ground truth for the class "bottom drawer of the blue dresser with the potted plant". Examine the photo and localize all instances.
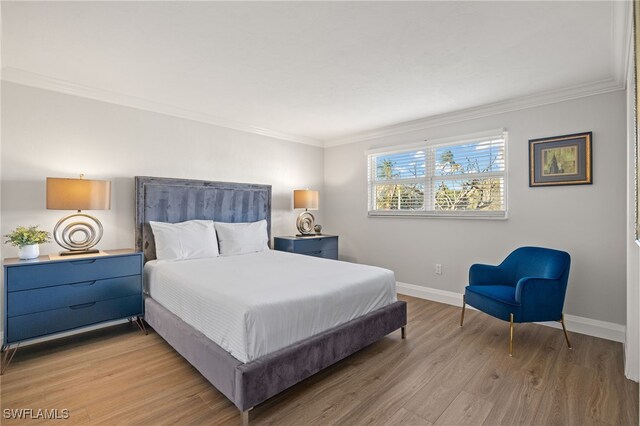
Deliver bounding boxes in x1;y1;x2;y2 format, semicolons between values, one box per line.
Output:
6;294;142;343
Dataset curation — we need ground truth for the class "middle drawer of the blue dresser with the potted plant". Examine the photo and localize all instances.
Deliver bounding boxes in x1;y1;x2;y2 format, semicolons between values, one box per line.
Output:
7;275;142;317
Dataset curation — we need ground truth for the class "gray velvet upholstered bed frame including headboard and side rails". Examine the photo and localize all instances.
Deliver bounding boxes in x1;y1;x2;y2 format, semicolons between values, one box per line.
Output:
135;176;407;425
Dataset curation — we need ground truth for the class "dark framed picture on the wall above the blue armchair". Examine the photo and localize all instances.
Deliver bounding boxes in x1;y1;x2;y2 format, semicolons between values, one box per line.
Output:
529;132;593;187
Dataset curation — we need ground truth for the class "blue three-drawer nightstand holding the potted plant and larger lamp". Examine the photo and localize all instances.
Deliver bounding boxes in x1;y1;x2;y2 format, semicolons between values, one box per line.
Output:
2;250;145;372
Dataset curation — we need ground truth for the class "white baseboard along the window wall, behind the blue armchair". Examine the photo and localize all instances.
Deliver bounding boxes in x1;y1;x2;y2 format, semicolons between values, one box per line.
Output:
396;281;626;343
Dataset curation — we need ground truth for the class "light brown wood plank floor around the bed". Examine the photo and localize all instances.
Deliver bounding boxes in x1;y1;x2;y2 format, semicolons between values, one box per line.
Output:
0;296;638;425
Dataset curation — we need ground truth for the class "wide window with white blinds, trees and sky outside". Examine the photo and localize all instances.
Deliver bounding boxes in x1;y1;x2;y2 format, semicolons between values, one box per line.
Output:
367;129;507;218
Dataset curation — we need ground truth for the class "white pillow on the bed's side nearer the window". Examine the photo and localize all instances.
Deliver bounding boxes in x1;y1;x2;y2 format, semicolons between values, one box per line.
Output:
215;220;269;256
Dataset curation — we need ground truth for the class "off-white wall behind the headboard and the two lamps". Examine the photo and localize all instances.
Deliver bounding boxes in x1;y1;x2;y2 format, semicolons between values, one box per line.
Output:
0;82;324;257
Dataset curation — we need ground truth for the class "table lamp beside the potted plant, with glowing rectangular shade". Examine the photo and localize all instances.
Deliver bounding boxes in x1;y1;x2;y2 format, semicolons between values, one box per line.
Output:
47;175;111;256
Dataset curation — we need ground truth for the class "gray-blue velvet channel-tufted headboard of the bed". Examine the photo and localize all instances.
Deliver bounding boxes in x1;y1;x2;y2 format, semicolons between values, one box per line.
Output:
135;176;271;262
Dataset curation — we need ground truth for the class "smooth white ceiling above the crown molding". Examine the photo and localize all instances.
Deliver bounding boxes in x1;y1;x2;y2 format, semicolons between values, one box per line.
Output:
2;2;626;145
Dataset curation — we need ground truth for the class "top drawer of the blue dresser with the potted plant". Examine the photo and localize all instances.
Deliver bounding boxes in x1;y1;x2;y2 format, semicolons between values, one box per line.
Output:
7;254;142;292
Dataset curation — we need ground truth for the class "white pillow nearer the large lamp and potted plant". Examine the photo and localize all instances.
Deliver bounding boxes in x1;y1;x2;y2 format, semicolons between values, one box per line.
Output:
149;220;220;260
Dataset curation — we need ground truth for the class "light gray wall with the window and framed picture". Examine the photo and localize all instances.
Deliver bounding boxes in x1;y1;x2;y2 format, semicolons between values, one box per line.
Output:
323;91;627;324
